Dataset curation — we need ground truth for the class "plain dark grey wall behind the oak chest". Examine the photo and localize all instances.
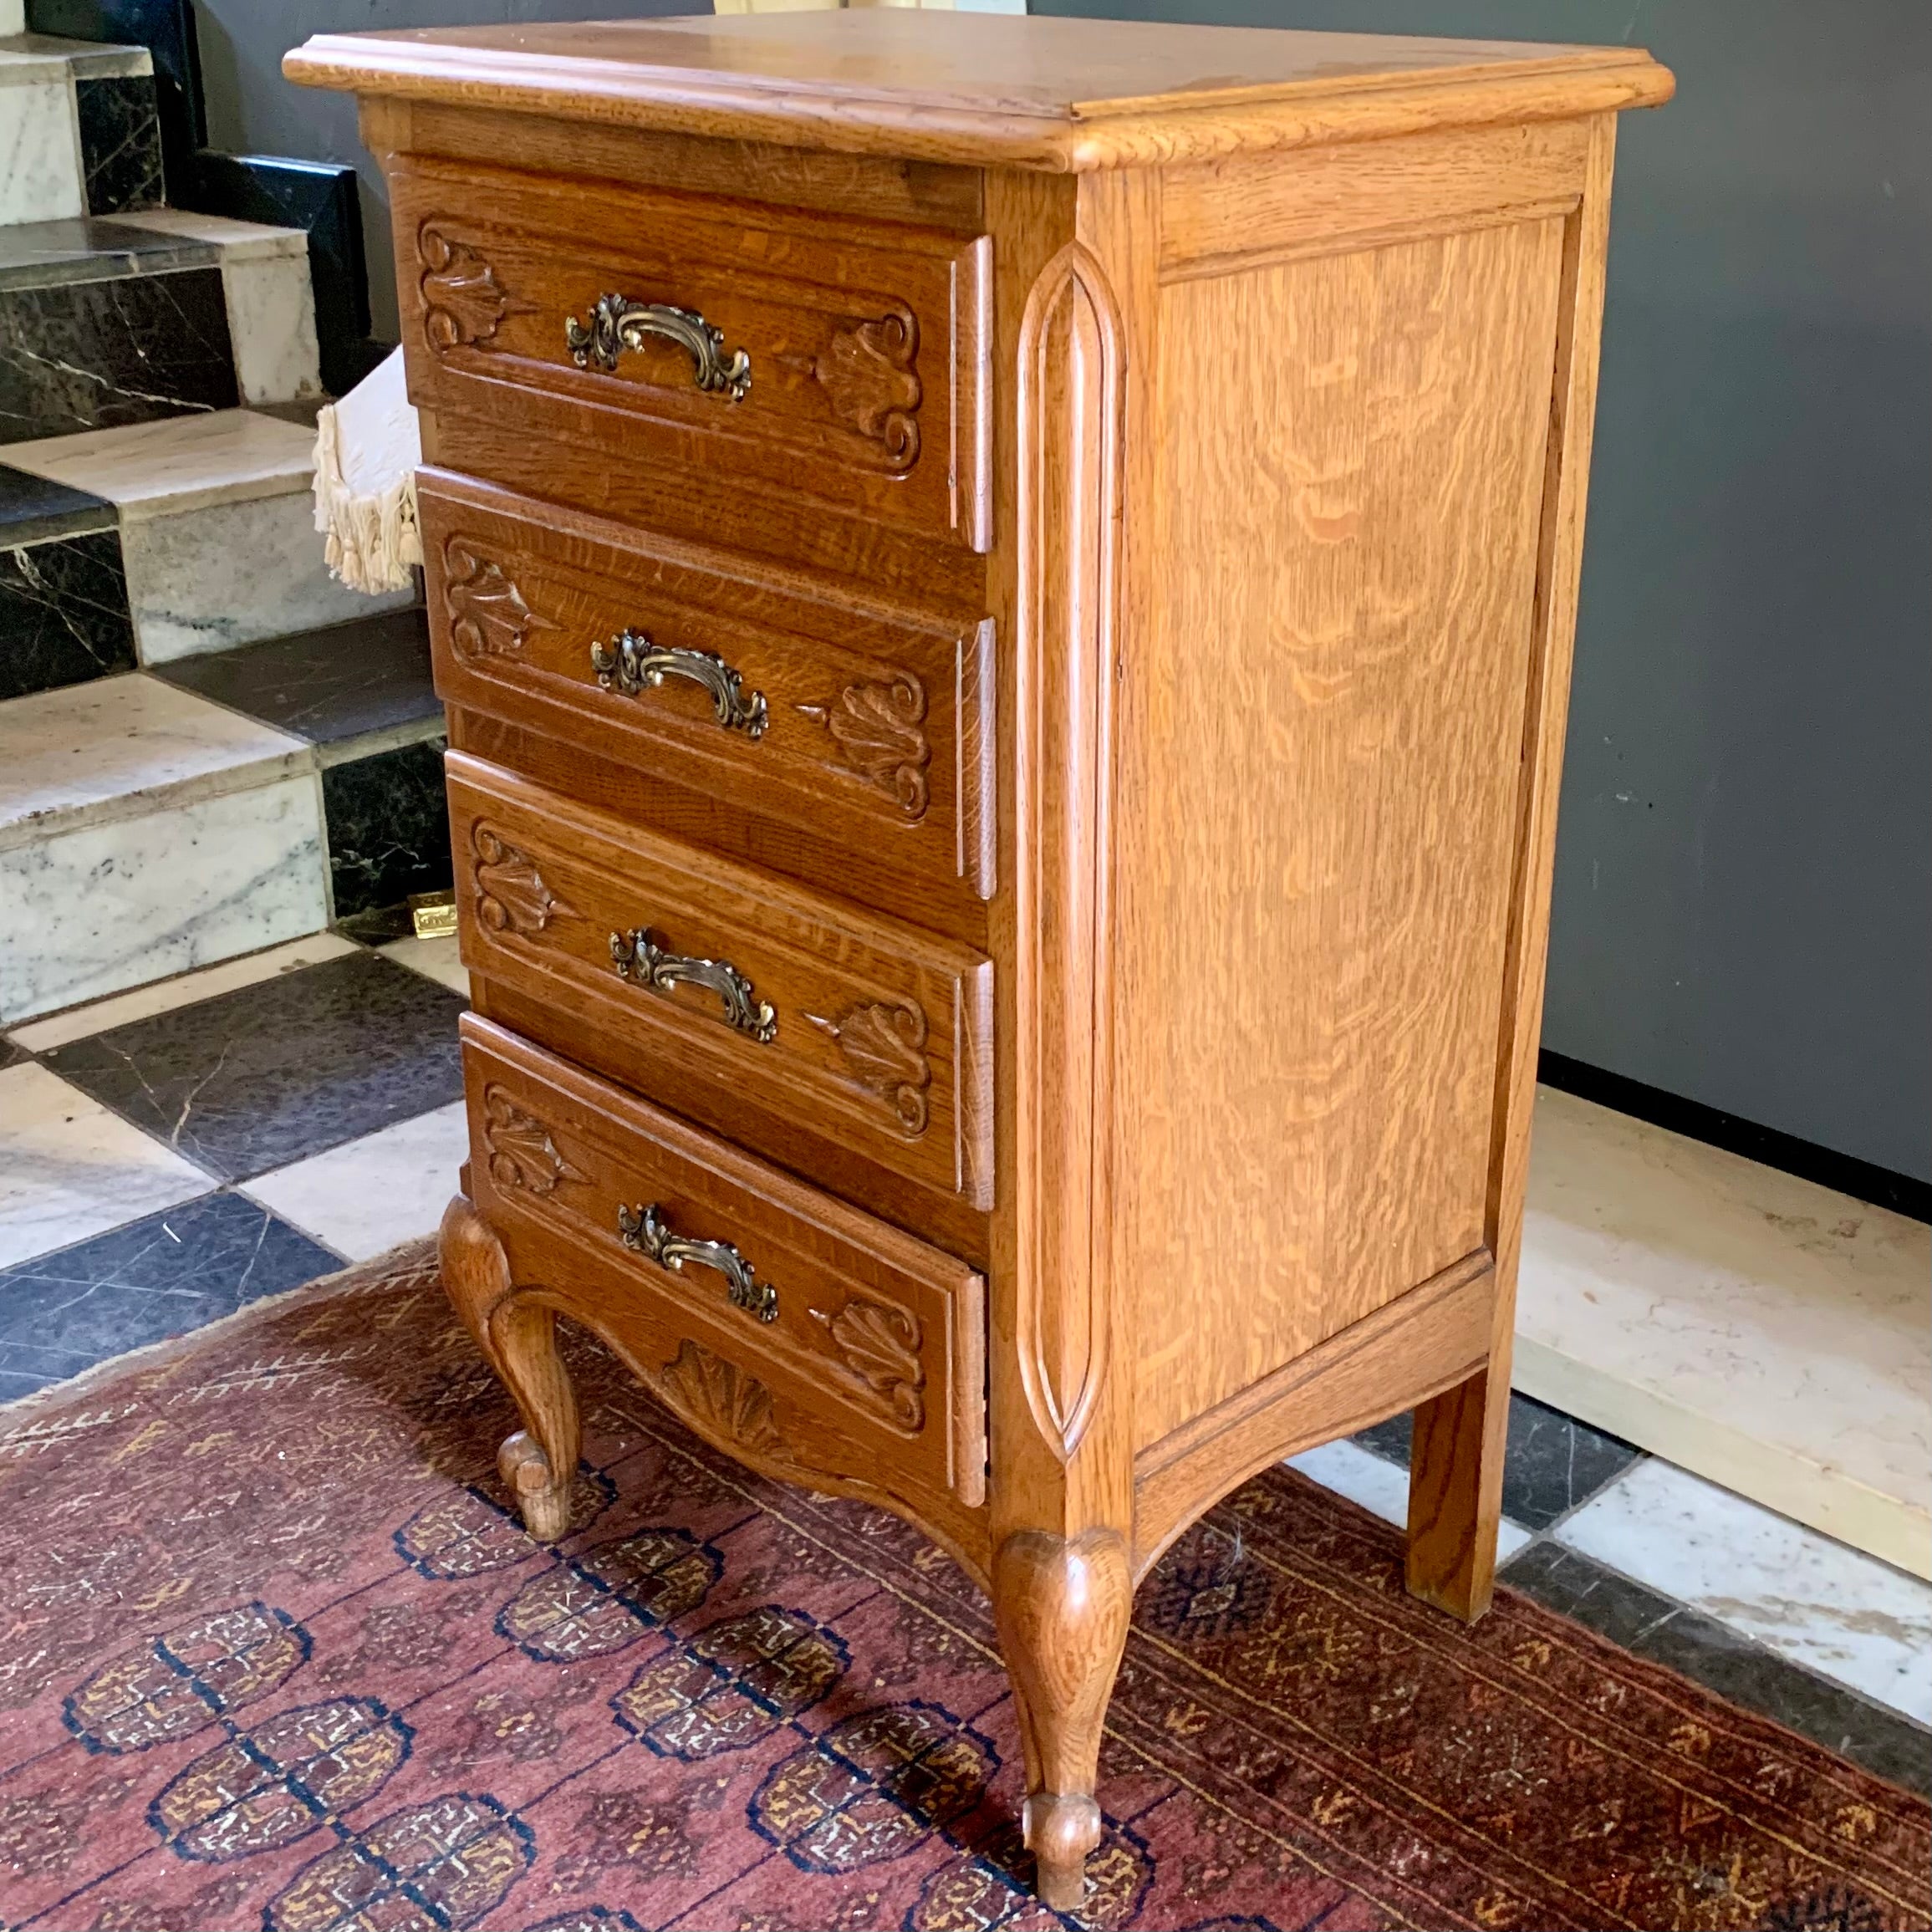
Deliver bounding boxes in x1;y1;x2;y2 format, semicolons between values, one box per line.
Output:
197;0;1932;1179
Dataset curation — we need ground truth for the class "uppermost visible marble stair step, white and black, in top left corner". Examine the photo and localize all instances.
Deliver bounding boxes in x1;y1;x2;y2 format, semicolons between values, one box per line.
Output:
0;32;162;226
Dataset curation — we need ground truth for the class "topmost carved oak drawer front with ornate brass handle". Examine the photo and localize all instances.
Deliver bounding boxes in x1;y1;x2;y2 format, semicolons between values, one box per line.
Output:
390;159;991;551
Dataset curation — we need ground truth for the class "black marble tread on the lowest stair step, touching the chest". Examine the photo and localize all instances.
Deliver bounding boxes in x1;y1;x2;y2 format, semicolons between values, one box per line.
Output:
155;609;442;744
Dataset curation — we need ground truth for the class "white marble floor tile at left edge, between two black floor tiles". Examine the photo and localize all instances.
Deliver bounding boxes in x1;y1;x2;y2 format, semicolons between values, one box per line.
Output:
0;1063;215;1267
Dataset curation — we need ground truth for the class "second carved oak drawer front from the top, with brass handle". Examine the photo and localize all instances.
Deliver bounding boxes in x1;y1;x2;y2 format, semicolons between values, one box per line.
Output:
417;470;993;899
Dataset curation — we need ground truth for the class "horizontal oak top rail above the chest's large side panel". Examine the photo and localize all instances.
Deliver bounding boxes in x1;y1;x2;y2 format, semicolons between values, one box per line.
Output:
1161;122;1590;278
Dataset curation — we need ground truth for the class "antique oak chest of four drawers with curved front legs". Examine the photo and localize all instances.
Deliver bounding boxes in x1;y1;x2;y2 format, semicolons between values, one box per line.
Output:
288;12;1671;1907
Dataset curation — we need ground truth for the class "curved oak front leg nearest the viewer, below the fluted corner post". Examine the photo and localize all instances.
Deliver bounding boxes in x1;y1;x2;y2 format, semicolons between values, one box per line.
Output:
993;1530;1134;1913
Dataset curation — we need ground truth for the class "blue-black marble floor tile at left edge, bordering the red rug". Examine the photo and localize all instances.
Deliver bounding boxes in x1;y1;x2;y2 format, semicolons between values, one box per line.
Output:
0;1192;344;1403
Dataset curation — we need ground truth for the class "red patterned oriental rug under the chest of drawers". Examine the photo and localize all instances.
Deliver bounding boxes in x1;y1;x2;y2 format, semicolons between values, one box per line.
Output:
0;1256;1932;1932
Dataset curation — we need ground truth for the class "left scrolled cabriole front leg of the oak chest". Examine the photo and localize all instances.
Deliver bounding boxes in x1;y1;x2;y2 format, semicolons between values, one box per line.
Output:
439;1194;582;1542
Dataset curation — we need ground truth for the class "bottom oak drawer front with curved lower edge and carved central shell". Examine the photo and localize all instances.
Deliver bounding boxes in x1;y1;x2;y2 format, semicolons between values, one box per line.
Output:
461;1014;986;1505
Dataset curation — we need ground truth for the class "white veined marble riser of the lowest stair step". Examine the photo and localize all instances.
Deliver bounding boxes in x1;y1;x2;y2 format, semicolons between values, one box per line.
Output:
0;772;329;1022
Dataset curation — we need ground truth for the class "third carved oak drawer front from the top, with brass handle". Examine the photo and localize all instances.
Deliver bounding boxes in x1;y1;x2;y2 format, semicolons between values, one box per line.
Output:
445;752;993;1207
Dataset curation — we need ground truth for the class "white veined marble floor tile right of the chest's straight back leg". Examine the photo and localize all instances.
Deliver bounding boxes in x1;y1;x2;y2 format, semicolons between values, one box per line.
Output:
1552;1456;1932;1723
